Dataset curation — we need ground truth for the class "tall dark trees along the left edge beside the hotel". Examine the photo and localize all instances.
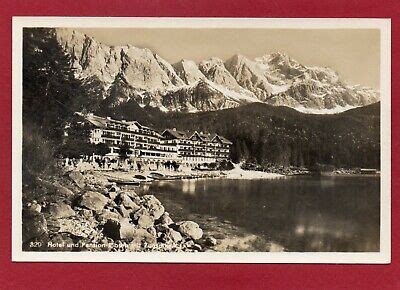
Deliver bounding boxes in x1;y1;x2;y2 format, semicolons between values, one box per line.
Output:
22;28;104;177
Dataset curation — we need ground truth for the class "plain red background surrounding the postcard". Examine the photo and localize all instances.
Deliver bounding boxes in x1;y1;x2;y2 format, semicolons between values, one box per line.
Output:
0;0;400;289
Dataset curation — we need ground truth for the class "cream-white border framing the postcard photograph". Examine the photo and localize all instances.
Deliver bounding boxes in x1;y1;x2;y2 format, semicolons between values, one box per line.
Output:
11;17;391;264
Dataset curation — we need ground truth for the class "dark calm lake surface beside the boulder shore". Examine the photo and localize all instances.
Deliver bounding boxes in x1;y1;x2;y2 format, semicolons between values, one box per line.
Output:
142;176;380;252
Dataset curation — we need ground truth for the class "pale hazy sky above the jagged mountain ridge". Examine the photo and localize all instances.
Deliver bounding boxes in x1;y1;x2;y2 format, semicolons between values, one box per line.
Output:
78;28;380;90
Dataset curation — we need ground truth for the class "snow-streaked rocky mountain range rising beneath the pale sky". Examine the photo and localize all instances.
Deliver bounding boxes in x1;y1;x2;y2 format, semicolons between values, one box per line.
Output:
56;29;379;113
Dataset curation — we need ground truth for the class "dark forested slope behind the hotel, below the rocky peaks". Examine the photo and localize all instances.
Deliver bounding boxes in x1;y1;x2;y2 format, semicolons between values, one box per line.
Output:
98;101;380;168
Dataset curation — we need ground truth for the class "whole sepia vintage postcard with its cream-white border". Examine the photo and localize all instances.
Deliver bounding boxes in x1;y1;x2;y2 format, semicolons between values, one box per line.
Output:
12;17;391;263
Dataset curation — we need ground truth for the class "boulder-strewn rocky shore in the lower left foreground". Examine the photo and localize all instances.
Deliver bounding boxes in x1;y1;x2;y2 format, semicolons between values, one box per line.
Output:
22;171;217;252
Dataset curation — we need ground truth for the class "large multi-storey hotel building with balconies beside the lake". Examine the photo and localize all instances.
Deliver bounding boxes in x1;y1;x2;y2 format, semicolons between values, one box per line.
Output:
83;114;232;168
